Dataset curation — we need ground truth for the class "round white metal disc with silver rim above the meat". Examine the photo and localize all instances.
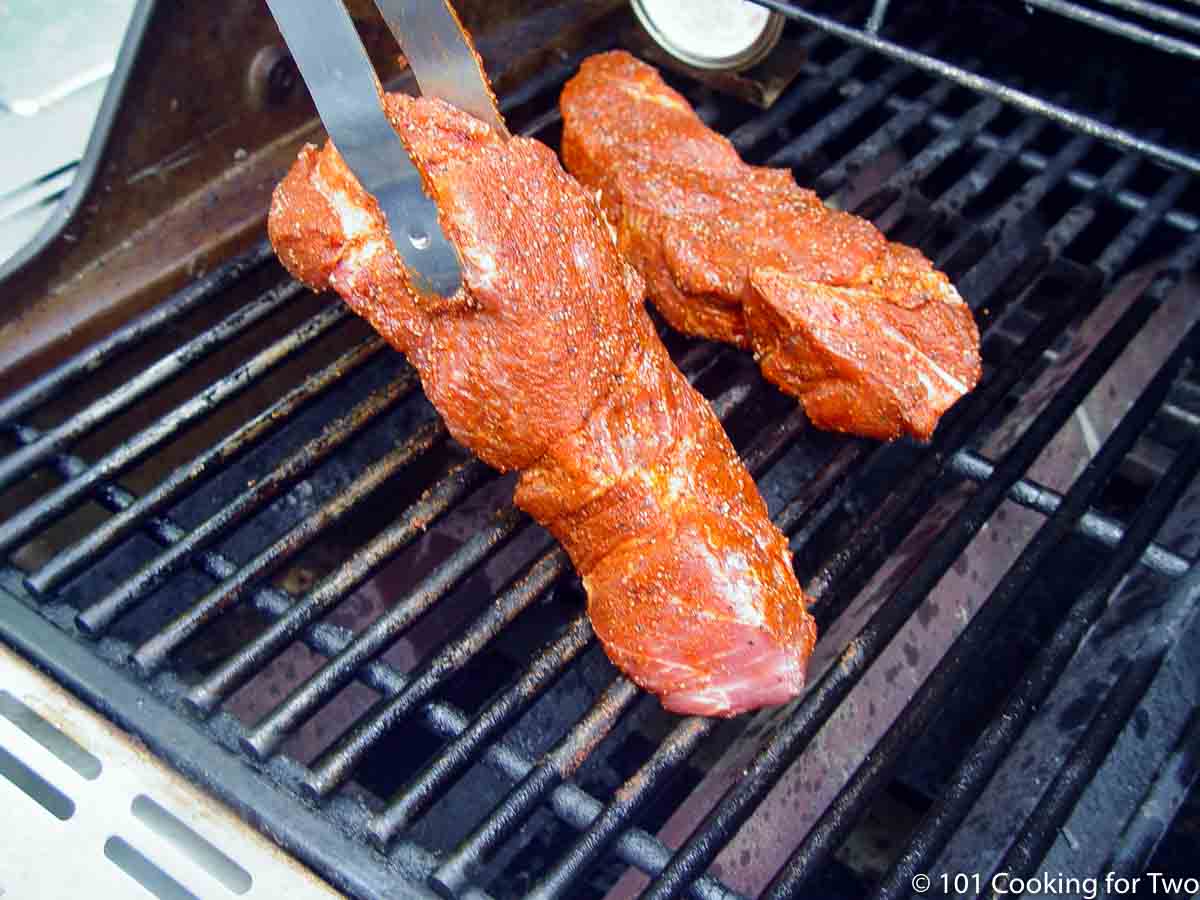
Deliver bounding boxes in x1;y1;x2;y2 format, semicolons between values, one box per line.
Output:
631;0;784;71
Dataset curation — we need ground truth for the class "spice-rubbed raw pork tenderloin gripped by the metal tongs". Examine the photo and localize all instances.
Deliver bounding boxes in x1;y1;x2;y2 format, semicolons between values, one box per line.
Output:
269;88;816;715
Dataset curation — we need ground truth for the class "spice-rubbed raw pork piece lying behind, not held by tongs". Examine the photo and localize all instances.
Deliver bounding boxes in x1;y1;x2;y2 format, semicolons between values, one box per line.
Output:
560;50;980;440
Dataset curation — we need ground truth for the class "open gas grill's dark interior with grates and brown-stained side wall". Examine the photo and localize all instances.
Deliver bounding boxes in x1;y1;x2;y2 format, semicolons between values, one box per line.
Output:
0;0;1200;900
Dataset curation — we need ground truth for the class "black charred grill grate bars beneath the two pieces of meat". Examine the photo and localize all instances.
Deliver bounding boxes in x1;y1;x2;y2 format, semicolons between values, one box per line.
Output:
0;10;1200;898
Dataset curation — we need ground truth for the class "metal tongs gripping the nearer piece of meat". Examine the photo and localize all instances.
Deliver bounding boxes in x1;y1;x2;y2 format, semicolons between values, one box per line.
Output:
266;0;509;296
